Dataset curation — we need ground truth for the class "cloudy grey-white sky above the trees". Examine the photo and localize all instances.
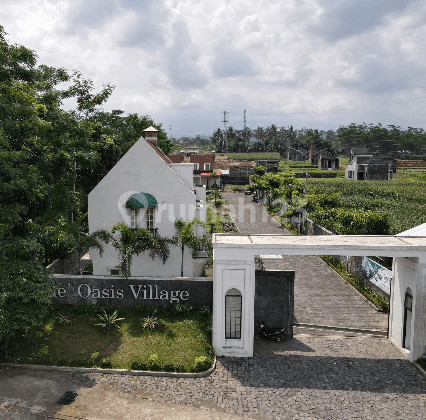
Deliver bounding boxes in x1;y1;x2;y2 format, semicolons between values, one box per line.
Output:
0;0;426;137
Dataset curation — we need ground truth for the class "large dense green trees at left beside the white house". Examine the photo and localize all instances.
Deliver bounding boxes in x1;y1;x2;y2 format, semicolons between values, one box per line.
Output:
0;26;171;348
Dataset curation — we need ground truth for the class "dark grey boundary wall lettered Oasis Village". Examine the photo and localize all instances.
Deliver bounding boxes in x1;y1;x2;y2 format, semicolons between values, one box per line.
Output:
53;274;213;308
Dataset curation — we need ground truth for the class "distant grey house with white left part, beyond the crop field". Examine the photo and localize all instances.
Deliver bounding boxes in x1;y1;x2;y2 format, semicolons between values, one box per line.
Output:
345;155;396;181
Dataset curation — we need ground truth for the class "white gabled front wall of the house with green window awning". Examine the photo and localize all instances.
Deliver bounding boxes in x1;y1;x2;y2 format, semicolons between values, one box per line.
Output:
88;138;196;276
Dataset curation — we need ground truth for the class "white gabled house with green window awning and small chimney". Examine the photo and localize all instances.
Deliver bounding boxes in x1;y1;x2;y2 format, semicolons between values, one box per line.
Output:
88;127;206;276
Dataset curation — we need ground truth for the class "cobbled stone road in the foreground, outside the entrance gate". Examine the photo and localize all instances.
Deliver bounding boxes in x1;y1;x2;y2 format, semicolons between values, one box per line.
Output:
0;335;426;420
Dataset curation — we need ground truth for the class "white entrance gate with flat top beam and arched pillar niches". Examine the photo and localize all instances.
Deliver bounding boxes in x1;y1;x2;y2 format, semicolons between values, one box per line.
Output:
213;233;426;361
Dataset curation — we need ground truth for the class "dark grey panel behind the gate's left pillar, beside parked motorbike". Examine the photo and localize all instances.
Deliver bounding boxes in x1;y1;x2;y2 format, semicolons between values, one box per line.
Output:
254;270;294;337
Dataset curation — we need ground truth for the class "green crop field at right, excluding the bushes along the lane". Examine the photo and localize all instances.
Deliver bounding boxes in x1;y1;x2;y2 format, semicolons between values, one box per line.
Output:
308;179;426;234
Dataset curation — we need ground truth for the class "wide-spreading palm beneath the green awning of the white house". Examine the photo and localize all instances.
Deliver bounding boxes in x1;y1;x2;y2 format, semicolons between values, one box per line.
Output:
93;223;172;279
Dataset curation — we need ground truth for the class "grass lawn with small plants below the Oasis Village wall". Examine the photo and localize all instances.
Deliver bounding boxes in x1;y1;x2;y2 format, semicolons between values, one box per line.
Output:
6;304;213;372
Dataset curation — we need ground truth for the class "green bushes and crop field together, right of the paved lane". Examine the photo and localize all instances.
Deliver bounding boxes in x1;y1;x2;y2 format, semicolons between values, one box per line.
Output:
252;170;426;235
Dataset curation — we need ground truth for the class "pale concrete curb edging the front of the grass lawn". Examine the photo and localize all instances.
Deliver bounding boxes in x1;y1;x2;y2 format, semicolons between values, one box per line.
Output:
0;356;216;379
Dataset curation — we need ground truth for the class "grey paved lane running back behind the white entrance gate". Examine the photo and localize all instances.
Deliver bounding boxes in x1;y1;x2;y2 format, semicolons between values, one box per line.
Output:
223;193;387;334
